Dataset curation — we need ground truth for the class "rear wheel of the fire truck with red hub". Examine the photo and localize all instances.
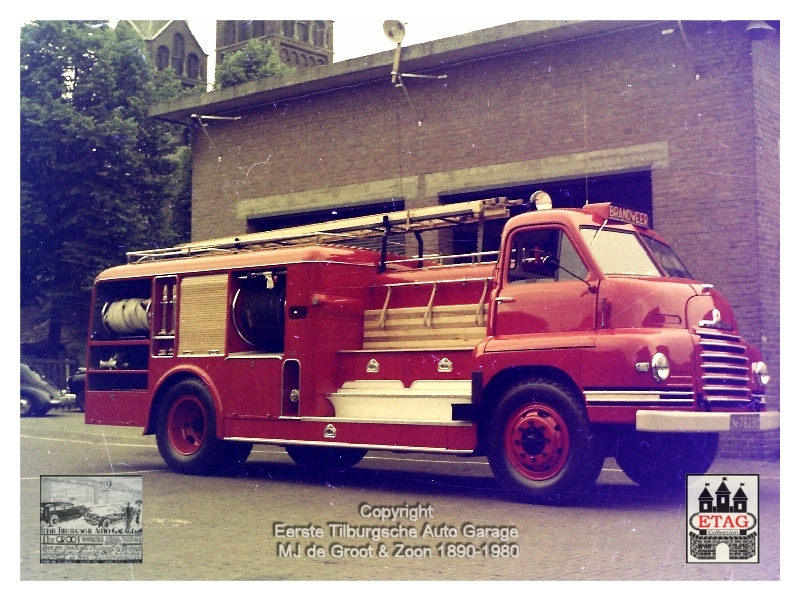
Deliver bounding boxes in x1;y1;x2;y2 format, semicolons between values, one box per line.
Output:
156;379;253;475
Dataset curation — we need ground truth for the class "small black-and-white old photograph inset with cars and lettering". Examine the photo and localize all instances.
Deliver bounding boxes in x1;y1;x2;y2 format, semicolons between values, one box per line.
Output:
39;475;144;563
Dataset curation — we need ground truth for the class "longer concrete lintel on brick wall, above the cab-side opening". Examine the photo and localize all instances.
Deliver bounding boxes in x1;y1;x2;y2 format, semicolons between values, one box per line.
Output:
424;141;669;197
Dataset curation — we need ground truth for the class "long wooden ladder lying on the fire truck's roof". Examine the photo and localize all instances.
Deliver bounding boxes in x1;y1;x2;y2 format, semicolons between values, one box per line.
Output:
127;197;522;263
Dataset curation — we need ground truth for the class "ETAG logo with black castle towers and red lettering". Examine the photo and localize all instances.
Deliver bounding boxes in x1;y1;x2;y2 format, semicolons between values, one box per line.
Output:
686;475;758;563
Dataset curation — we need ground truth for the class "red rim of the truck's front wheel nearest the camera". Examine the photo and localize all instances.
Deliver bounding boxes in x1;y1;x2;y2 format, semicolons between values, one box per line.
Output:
504;403;569;481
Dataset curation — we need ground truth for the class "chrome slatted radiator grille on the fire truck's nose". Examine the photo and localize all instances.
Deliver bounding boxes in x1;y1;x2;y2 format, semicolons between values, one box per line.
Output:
697;329;750;406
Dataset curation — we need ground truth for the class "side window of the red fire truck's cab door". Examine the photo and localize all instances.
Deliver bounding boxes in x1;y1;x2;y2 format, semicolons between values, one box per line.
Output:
508;229;588;283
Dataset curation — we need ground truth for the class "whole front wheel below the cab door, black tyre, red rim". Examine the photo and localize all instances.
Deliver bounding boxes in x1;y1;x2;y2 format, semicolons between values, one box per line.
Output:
487;380;604;502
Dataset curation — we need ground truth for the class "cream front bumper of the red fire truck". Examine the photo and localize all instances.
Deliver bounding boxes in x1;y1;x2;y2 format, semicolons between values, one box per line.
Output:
636;410;780;433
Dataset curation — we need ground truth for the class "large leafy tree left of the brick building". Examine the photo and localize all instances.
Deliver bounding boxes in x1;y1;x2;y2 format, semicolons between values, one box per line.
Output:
20;21;187;355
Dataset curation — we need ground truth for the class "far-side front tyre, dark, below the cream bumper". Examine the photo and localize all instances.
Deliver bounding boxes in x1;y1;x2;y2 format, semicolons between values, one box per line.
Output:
615;428;719;490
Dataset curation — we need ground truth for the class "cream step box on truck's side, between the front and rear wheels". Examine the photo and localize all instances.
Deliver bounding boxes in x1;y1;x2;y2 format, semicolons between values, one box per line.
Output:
328;380;472;424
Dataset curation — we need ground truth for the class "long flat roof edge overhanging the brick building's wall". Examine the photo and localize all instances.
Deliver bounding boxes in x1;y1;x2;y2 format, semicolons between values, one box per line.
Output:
149;21;655;124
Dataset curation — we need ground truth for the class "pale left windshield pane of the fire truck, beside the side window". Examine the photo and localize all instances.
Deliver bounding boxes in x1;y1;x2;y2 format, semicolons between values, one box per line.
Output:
581;227;661;277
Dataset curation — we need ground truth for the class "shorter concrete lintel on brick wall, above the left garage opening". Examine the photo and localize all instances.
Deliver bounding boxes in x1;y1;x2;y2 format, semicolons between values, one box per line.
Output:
236;177;419;220
